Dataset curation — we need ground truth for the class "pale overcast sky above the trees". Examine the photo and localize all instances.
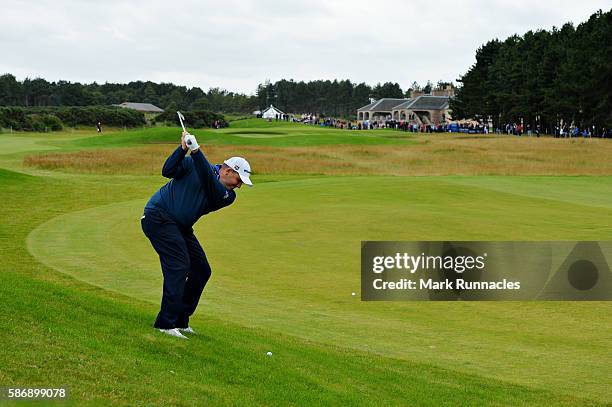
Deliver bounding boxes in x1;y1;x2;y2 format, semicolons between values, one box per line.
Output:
0;0;611;94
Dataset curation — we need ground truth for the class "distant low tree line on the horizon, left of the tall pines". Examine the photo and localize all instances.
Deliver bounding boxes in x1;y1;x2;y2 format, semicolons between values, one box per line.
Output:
0;74;449;118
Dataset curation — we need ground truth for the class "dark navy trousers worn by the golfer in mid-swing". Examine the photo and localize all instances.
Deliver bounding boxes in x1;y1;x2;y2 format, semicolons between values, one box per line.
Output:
140;210;211;329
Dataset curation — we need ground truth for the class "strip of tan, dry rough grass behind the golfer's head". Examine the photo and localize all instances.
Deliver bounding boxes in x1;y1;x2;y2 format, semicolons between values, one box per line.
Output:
24;135;612;175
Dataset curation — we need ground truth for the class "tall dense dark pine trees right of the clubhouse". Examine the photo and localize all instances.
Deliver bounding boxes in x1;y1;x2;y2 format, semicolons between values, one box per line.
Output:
450;10;612;131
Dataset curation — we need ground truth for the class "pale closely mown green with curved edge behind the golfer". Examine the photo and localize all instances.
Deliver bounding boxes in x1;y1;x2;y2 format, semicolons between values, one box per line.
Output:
28;177;612;401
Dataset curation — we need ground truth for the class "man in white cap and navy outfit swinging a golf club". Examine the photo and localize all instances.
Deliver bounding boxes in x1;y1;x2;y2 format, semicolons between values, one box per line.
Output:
141;131;253;339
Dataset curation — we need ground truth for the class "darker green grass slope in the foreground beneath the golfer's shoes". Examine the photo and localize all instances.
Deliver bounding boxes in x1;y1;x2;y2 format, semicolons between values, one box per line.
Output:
0;264;588;405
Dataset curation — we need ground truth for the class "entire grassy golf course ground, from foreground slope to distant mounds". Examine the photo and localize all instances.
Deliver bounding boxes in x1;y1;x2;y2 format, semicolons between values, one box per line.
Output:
0;119;612;406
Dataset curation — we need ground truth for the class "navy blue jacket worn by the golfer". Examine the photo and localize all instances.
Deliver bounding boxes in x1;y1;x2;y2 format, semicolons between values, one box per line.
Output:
145;146;236;231
